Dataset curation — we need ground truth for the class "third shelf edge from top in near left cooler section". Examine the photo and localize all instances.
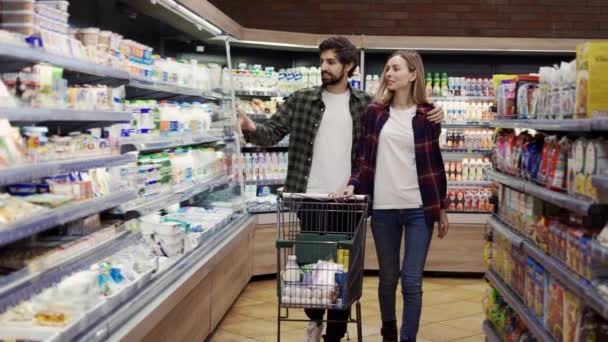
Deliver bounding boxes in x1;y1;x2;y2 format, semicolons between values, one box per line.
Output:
0;153;137;185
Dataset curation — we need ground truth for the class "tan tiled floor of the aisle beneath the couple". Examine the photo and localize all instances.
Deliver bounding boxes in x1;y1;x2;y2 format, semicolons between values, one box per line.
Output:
210;277;486;342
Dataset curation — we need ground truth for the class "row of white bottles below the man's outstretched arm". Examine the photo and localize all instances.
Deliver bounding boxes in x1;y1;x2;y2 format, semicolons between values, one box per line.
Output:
233;152;288;181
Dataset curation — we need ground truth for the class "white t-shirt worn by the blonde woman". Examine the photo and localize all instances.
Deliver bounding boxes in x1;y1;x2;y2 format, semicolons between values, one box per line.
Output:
374;106;422;209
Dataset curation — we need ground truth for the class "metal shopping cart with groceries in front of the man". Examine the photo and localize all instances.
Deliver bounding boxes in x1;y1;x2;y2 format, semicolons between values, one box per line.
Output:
276;193;368;341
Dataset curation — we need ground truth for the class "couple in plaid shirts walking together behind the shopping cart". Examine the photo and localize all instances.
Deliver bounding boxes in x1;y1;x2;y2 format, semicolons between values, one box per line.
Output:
239;37;448;342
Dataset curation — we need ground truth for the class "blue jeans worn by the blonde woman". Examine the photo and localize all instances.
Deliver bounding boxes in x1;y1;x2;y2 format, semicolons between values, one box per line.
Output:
372;208;433;341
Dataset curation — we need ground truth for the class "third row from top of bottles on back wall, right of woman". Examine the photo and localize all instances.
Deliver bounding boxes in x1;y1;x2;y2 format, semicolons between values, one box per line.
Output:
439;128;494;150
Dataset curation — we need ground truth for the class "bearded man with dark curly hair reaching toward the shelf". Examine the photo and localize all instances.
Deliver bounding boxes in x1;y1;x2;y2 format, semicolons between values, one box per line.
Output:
239;37;443;342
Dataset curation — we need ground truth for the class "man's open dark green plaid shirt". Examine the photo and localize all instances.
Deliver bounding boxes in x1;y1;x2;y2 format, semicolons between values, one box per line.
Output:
245;85;372;193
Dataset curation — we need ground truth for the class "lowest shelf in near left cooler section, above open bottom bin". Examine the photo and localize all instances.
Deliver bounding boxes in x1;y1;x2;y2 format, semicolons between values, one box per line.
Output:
0;225;140;312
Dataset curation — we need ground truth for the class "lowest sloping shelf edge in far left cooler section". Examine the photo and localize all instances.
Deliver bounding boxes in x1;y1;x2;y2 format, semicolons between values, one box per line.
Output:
118;176;232;216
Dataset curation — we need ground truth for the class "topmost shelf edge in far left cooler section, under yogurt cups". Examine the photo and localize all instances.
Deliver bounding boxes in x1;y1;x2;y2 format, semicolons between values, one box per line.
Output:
127;77;225;101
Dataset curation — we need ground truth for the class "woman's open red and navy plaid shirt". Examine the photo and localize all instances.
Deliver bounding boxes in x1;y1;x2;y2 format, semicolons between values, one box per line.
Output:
348;104;447;223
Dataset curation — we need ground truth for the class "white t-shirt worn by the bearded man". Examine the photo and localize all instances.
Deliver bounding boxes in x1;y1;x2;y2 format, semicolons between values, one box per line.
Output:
306;91;353;194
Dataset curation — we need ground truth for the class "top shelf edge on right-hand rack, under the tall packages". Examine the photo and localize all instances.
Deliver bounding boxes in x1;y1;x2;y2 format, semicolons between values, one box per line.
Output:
490;118;608;132
